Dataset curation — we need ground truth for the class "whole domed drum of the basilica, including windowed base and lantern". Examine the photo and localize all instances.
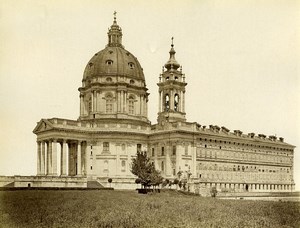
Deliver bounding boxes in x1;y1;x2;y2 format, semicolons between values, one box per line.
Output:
78;13;149;126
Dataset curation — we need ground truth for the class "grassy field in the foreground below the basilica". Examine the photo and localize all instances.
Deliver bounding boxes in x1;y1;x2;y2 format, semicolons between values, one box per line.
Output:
0;190;300;228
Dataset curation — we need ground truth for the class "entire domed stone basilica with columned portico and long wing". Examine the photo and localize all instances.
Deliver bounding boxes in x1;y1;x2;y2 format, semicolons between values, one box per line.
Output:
28;13;295;193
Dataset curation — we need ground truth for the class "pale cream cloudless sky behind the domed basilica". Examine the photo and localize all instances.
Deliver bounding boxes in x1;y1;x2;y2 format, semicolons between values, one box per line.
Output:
0;0;300;190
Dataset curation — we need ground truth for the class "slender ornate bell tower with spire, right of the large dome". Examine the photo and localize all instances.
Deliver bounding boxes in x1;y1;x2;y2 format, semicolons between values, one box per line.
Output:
157;37;187;124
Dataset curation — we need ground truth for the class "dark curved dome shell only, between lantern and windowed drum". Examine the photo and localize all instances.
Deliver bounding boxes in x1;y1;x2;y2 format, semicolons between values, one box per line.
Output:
83;46;145;80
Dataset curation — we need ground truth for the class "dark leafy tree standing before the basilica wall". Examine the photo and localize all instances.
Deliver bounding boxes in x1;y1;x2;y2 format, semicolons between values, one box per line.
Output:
131;151;163;188
